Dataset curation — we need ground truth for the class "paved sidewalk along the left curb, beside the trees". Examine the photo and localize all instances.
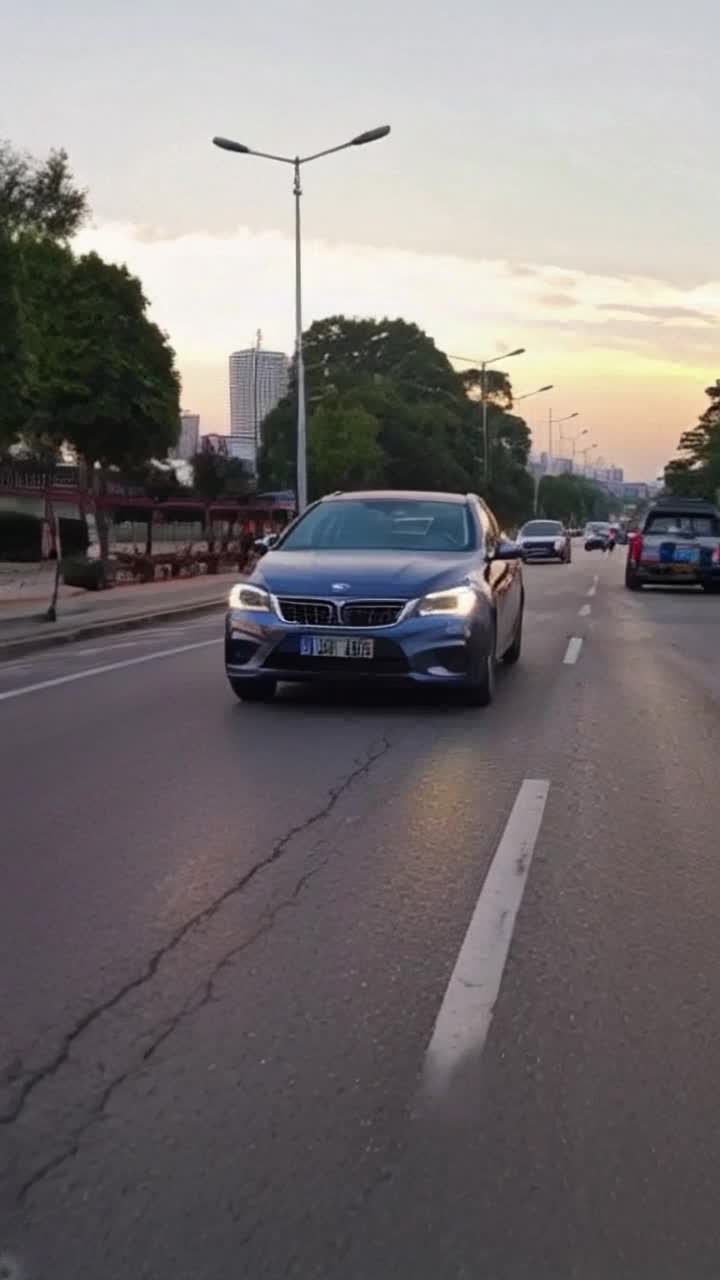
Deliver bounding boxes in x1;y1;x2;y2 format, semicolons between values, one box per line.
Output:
0;576;238;660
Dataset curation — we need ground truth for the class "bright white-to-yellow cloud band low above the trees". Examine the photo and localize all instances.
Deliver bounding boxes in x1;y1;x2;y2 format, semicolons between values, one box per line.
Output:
77;223;720;476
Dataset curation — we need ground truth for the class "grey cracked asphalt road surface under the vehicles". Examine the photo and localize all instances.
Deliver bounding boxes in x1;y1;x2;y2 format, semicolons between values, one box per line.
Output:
0;552;720;1280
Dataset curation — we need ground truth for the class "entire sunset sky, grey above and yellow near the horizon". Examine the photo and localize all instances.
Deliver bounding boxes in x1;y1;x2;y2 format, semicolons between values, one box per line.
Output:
0;0;720;479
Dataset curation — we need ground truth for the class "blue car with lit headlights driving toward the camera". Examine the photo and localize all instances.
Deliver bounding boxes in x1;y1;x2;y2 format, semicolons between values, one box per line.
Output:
225;490;524;707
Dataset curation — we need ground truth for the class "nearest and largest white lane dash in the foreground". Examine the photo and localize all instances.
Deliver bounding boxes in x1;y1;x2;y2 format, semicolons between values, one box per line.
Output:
423;778;550;1093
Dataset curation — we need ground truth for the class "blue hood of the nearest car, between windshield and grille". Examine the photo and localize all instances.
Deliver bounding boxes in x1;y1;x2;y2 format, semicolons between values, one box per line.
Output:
252;550;475;600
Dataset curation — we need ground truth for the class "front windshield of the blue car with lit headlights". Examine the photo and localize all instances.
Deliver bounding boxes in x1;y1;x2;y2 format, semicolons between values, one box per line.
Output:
282;498;474;552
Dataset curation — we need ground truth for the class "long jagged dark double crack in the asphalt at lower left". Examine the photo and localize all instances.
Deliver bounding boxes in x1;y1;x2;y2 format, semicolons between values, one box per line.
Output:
9;735;392;1202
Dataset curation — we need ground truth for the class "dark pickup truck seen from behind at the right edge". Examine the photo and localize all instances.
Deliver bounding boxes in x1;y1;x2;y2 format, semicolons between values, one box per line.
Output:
625;498;720;593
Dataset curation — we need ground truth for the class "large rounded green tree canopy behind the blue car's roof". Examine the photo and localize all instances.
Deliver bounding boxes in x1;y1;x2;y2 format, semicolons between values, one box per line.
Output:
260;316;532;520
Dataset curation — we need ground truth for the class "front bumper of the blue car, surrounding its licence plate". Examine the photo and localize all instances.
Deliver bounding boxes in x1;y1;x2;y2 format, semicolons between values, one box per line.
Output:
225;609;491;685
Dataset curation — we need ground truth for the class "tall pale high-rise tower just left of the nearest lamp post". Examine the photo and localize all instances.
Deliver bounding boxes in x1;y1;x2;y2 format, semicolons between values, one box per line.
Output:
228;345;288;470
